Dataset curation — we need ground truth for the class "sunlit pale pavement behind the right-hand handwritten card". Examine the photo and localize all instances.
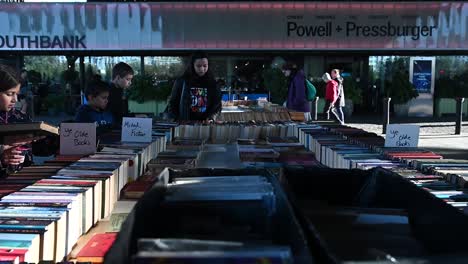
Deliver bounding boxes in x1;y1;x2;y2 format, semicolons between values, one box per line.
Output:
347;117;468;159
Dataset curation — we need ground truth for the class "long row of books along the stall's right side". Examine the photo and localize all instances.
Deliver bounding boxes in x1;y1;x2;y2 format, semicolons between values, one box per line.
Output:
298;125;468;213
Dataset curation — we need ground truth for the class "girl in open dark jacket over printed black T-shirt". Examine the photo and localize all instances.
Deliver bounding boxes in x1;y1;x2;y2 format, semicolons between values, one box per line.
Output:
168;52;221;121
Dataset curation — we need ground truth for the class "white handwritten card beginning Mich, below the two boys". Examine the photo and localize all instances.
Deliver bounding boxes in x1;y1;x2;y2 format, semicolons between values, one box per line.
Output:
122;117;153;142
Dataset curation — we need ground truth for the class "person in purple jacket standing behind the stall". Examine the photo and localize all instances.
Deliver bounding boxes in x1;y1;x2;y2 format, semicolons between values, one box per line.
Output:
283;63;310;113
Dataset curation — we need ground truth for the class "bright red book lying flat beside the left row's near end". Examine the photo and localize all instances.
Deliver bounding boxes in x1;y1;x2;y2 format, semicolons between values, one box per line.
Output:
76;233;117;263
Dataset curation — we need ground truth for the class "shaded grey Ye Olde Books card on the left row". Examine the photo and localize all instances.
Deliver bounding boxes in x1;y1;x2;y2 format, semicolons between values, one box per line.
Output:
60;123;96;155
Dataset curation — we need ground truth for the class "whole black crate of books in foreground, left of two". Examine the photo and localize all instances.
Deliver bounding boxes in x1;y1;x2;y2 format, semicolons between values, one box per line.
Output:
106;169;312;263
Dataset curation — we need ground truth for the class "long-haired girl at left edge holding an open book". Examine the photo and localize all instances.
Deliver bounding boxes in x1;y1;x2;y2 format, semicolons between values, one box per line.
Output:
0;65;58;177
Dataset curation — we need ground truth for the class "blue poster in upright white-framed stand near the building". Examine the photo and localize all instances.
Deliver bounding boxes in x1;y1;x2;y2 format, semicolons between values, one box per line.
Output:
408;57;436;117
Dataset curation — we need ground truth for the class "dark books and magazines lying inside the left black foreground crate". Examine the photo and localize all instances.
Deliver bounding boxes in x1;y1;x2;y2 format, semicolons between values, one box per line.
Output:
133;175;293;264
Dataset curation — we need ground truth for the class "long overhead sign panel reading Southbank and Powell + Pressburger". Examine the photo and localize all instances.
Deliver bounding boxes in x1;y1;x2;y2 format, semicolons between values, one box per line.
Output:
0;2;468;50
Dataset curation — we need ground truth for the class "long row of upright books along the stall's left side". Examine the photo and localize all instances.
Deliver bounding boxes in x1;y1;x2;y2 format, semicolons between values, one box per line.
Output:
0;129;165;263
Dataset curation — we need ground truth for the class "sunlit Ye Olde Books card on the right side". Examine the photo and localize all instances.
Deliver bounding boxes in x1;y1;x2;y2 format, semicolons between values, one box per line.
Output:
385;124;419;148
